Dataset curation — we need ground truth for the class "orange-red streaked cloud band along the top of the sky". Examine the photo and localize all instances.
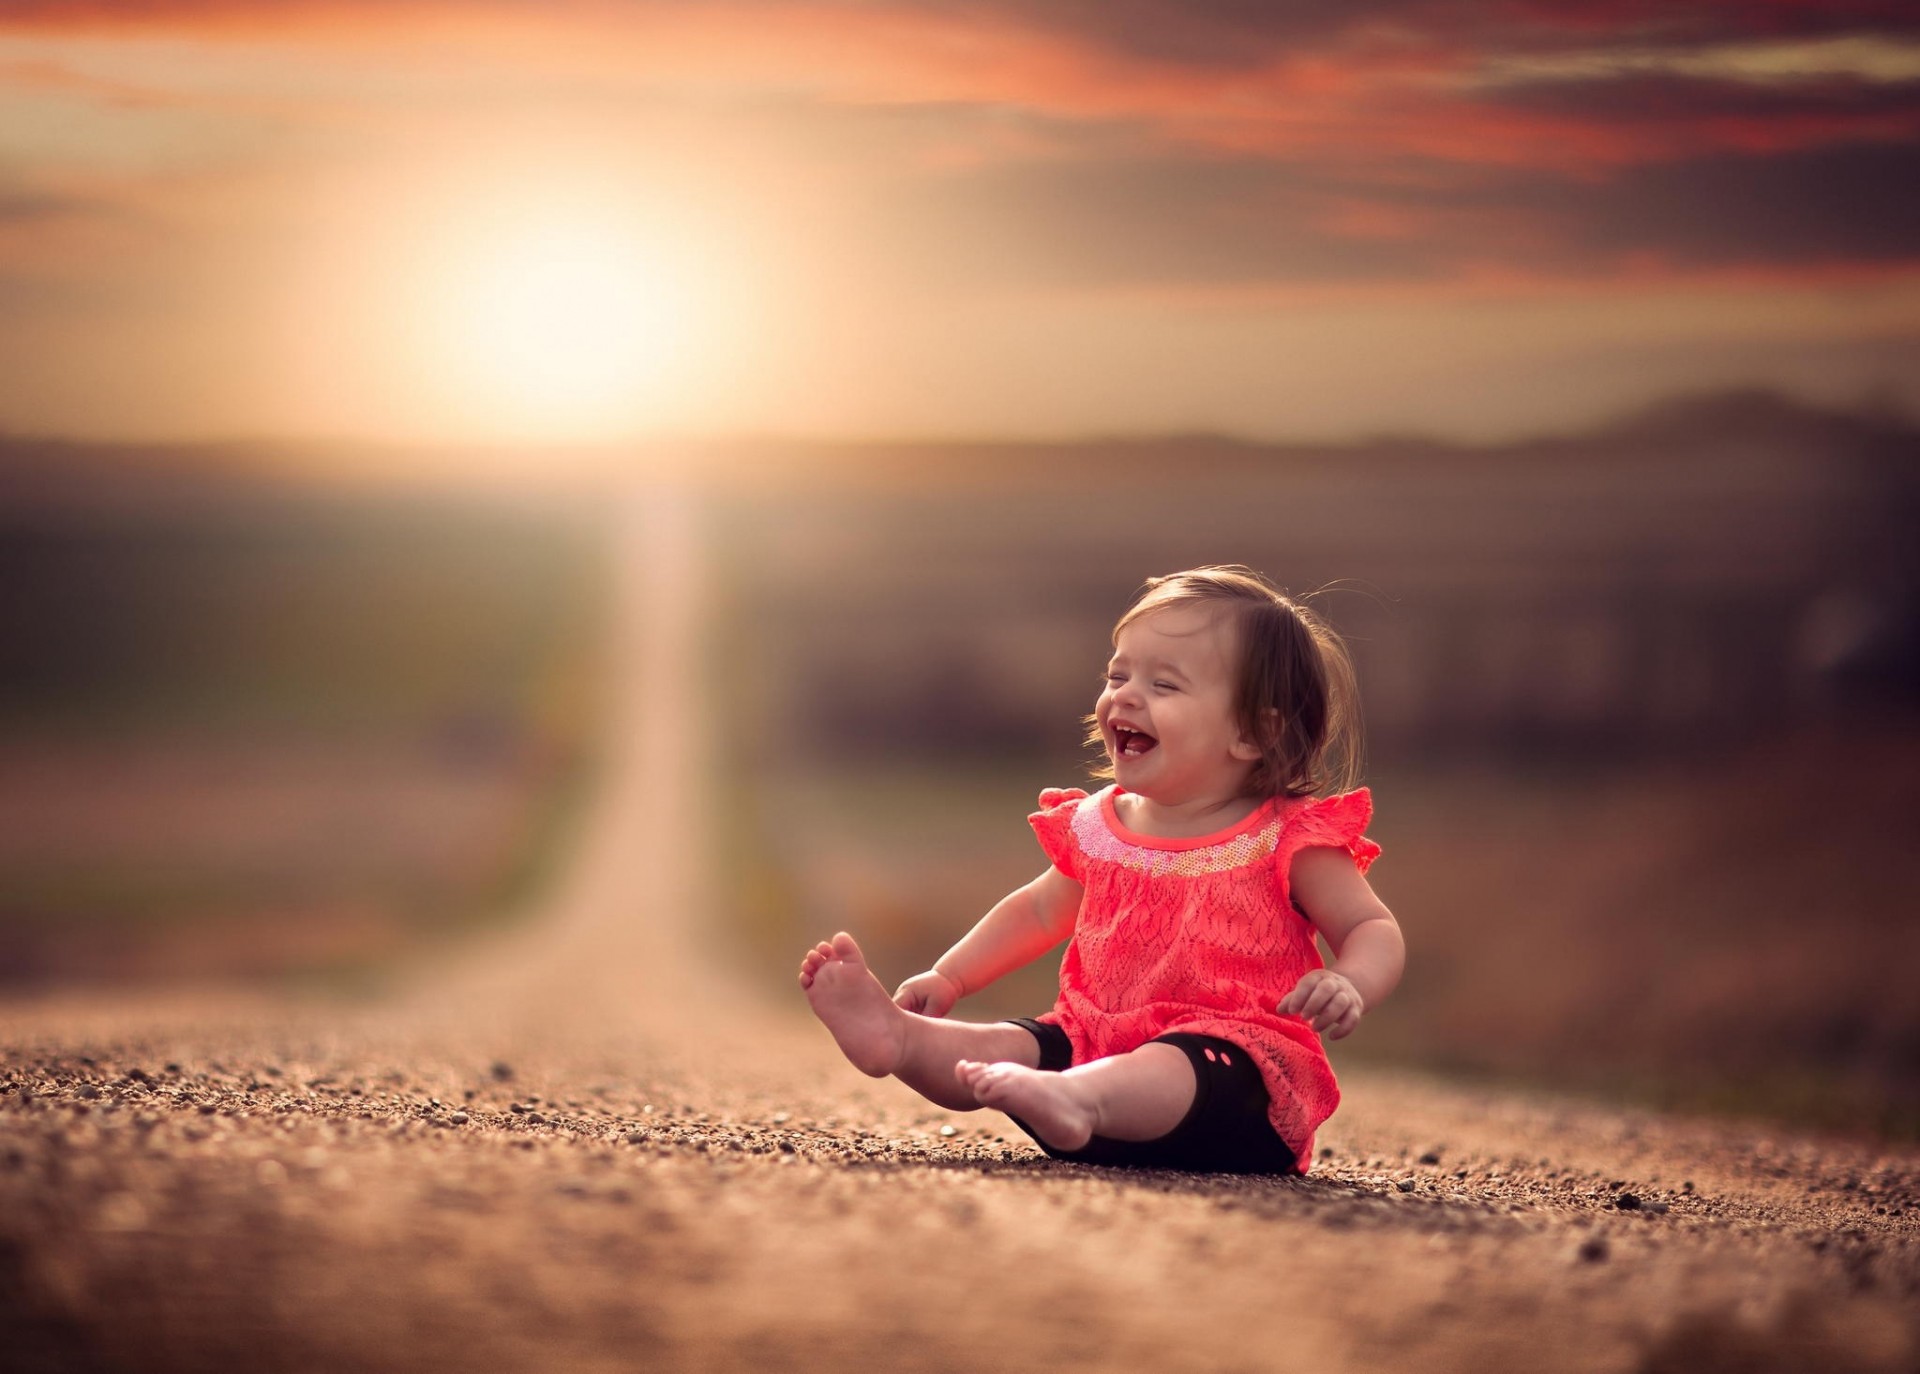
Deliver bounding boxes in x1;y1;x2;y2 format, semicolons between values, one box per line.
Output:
0;0;1920;182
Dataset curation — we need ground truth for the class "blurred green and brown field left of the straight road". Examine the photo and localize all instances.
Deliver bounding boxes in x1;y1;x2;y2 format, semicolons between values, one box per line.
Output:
0;464;605;984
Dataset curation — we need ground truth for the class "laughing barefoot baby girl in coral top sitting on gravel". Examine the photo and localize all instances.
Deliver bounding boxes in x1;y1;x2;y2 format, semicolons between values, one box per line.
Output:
801;566;1405;1173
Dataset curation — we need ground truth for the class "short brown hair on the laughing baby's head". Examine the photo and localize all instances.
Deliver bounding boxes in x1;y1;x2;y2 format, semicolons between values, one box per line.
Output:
1087;564;1361;796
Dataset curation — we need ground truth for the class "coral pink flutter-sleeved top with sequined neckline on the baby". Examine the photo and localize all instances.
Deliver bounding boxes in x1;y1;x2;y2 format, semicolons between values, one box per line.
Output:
1029;787;1380;1173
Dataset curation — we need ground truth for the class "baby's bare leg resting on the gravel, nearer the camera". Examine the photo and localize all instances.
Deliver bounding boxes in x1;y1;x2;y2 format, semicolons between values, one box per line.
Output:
954;1044;1198;1151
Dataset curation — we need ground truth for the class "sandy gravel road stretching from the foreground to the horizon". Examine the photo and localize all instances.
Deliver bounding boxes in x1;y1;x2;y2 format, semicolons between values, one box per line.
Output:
0;497;1920;1372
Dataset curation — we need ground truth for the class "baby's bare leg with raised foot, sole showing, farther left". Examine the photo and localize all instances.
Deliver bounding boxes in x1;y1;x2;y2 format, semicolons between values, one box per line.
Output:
801;933;1044;1111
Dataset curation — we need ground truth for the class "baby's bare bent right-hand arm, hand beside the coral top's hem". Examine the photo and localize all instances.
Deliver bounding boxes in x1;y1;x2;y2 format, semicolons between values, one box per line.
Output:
1277;844;1407;1040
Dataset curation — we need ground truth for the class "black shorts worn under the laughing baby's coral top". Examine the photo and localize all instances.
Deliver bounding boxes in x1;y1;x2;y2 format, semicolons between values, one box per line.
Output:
1012;1017;1298;1174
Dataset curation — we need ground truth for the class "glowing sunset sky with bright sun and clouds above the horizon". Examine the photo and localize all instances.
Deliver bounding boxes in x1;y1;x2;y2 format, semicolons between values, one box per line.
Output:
0;0;1920;441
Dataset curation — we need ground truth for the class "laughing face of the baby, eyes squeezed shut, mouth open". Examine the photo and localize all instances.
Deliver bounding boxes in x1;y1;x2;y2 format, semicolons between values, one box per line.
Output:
1094;606;1260;806
